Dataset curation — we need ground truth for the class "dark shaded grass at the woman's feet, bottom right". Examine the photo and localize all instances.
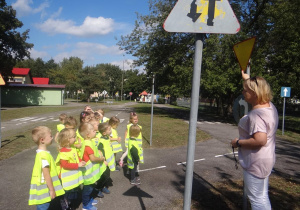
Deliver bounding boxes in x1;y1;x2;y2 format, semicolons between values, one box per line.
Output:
173;165;300;210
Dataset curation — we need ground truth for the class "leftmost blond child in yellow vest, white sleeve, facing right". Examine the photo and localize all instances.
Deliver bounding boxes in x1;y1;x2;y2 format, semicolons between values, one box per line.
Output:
28;126;65;209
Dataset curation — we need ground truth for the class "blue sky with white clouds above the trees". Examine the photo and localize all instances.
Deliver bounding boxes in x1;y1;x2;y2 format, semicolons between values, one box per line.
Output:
6;0;149;70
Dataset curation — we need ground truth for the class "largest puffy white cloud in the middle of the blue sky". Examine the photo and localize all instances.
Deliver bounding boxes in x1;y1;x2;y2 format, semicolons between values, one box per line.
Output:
37;16;115;37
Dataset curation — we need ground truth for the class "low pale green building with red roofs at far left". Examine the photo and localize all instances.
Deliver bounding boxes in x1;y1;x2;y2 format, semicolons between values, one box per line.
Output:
1;68;65;106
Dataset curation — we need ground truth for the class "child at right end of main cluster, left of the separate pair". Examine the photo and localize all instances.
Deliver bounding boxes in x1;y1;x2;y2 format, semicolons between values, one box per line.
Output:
108;116;123;171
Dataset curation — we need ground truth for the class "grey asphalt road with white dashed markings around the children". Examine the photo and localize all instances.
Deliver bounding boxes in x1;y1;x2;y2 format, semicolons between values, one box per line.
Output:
0;104;300;210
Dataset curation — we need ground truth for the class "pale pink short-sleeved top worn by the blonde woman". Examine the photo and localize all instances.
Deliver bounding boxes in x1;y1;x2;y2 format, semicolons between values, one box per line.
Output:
238;102;278;178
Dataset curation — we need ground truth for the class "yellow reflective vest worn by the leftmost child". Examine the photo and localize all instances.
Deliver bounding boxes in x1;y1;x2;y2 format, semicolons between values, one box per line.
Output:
28;151;65;205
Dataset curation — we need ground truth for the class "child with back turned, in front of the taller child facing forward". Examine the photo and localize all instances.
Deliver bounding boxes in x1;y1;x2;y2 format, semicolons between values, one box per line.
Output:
127;124;144;185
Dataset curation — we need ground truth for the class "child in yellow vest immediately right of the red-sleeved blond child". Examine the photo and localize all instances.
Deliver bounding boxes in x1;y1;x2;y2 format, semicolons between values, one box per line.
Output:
98;123;116;194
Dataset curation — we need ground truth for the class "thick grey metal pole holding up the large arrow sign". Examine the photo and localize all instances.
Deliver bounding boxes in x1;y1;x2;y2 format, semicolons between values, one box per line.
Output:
183;34;203;210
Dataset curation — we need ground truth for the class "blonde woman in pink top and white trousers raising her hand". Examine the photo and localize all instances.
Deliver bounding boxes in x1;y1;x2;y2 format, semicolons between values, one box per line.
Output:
231;71;278;210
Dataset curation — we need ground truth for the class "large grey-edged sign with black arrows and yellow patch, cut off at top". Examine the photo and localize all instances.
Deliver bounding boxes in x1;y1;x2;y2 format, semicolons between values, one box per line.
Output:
164;0;240;34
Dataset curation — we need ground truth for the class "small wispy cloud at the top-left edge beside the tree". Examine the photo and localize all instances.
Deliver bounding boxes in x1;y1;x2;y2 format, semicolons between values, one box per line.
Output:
12;0;49;17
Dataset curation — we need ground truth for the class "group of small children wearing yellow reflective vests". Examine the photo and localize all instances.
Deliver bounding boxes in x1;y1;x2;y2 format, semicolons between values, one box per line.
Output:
29;106;144;210
